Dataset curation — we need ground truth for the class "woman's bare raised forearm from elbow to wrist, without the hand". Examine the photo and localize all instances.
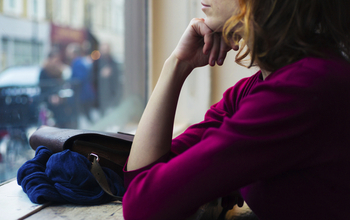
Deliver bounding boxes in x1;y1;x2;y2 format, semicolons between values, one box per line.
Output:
127;56;192;170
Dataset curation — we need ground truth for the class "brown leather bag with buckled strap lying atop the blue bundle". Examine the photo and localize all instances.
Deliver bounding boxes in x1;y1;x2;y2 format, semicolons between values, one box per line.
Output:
29;126;134;200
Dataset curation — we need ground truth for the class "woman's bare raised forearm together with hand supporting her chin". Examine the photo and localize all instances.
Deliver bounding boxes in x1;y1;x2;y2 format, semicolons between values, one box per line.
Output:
127;19;231;170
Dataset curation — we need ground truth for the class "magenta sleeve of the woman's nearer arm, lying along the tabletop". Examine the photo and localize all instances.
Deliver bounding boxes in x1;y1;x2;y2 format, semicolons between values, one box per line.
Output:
123;59;349;220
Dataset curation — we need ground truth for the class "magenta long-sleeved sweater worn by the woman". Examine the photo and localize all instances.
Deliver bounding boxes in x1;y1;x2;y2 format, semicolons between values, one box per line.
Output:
123;55;350;220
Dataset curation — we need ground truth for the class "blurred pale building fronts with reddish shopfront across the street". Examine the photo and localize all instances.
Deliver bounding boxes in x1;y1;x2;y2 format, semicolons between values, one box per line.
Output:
0;0;124;70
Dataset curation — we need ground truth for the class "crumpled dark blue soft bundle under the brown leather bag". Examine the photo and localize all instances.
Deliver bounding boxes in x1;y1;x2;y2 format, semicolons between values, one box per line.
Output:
17;146;125;205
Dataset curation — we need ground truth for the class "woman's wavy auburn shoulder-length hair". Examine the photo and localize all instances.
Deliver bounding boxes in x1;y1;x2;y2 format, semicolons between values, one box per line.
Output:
223;0;350;71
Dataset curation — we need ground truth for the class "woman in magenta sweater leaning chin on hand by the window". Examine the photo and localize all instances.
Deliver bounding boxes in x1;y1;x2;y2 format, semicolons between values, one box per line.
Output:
123;0;350;220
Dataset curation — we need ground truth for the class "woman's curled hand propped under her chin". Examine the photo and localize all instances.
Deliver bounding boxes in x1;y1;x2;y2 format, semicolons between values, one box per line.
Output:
172;18;238;72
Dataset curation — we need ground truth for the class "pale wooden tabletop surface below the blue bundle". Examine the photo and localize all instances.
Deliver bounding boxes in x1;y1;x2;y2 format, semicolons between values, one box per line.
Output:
0;179;124;220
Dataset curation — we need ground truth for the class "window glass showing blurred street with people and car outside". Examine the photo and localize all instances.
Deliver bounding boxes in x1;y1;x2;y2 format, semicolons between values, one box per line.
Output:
0;0;147;182
